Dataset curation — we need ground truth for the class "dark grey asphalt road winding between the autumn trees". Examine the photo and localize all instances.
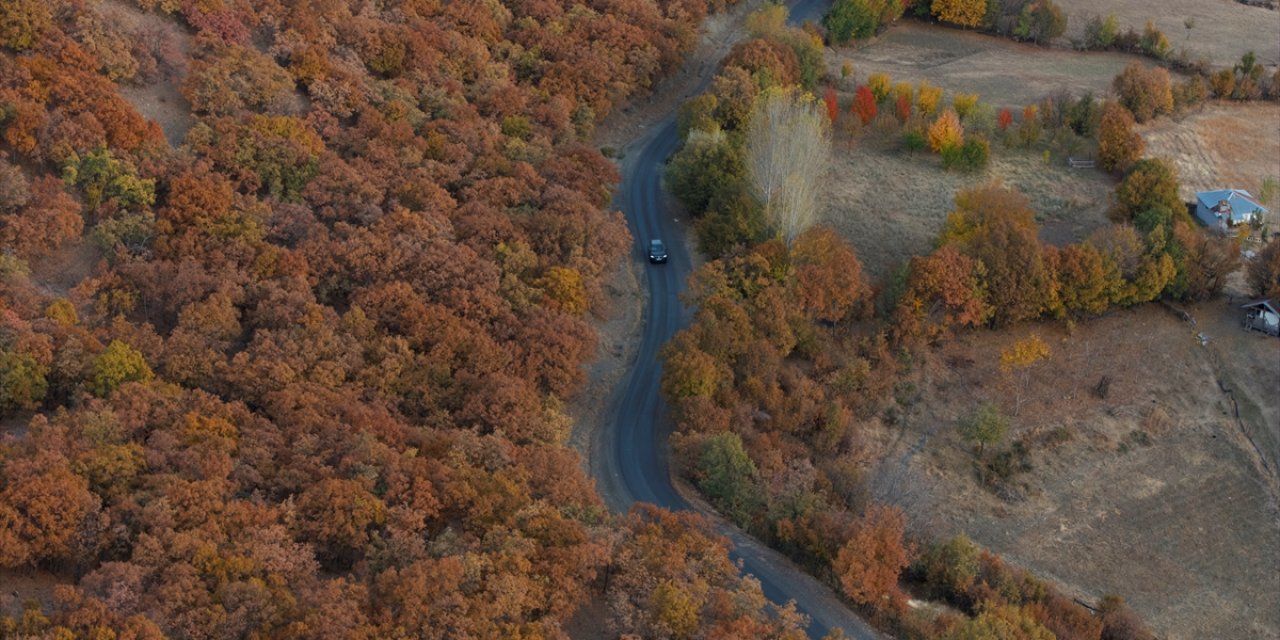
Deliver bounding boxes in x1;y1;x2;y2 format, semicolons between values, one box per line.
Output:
593;0;882;640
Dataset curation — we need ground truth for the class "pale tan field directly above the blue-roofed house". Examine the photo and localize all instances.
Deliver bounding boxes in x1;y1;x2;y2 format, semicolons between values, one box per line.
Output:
1142;102;1280;200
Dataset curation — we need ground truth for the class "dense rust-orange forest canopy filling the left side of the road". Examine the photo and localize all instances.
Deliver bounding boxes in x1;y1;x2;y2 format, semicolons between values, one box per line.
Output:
0;0;768;637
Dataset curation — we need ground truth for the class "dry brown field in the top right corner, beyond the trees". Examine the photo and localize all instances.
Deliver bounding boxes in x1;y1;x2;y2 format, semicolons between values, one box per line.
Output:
1057;0;1280;68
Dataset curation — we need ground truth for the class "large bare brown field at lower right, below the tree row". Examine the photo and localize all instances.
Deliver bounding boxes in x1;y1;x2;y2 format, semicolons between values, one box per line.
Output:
902;301;1280;639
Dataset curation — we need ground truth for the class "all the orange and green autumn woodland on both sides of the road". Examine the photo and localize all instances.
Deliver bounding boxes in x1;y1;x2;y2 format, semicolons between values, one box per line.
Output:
0;0;1280;640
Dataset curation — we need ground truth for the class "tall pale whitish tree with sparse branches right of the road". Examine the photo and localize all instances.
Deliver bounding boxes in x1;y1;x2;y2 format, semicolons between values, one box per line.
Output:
746;88;831;247
